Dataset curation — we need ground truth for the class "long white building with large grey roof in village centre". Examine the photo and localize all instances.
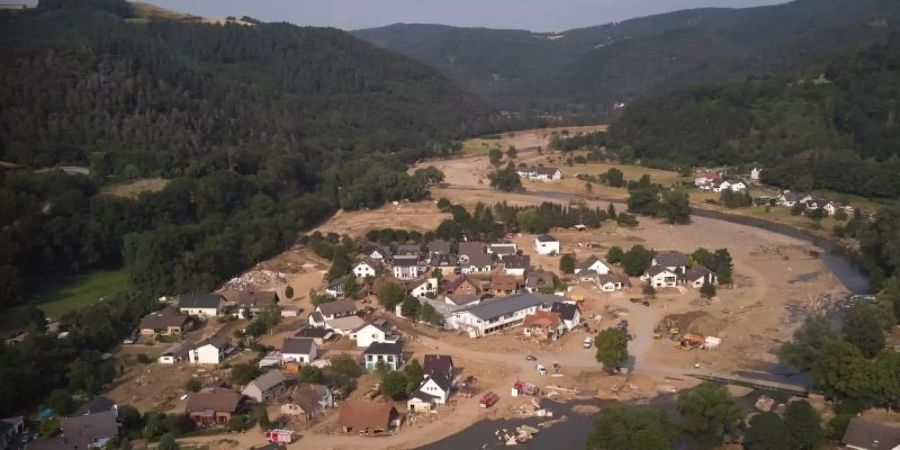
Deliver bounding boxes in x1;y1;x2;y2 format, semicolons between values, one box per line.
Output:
447;294;562;337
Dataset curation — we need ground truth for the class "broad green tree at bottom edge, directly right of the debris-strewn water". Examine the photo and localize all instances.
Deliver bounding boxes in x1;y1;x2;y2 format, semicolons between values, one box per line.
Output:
585;405;673;450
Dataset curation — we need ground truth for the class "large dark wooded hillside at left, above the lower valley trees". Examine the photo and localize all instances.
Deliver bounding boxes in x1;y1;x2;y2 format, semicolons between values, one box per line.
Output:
0;0;500;176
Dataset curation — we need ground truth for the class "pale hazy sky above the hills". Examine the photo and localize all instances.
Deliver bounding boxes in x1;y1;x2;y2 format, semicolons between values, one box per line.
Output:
32;0;783;31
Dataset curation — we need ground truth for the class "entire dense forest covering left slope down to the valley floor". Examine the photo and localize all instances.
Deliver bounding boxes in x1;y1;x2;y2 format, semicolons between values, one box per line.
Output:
0;0;498;308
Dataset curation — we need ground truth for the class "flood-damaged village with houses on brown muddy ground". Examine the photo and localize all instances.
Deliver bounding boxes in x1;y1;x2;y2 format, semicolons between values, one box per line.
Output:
5;127;880;449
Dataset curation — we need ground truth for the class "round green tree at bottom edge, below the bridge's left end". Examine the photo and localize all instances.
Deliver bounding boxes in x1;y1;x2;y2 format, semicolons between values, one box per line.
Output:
675;383;745;448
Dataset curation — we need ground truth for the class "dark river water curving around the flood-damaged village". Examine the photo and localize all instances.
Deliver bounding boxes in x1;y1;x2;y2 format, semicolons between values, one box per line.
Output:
419;191;871;450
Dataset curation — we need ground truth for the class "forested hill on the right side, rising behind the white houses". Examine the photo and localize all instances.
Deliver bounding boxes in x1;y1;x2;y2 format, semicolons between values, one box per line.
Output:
609;31;900;198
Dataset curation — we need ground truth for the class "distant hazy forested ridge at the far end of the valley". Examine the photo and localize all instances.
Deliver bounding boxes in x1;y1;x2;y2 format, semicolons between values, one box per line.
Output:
354;0;900;117
